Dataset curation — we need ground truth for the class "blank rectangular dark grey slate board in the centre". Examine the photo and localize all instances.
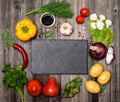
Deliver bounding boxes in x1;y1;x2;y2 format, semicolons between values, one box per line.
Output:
31;39;88;74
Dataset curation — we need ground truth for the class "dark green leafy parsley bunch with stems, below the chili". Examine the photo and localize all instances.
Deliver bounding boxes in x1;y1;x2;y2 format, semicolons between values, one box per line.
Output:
2;64;27;102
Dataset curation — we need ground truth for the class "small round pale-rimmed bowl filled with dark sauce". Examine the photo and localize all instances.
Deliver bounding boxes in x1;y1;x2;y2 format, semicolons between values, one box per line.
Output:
40;13;55;27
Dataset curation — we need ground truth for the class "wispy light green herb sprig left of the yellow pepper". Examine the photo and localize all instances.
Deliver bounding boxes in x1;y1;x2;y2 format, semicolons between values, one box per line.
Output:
1;27;15;49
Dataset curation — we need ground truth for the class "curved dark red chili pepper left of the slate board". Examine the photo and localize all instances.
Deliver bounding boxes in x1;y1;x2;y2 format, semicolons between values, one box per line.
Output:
13;43;28;70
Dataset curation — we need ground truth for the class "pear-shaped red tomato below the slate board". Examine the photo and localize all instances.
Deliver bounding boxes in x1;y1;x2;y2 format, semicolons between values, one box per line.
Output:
43;78;59;96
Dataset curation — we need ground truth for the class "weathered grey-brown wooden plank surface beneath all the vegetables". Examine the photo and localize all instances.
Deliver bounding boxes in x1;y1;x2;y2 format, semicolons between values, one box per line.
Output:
0;0;120;102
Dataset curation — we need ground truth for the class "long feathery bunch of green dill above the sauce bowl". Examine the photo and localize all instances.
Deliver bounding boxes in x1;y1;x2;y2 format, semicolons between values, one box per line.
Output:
24;1;73;18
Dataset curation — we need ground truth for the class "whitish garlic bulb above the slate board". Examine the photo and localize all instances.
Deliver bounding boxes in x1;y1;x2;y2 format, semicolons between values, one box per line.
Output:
60;22;73;35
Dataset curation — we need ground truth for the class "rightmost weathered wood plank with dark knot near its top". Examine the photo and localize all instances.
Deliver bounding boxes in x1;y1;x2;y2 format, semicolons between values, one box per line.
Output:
111;0;120;102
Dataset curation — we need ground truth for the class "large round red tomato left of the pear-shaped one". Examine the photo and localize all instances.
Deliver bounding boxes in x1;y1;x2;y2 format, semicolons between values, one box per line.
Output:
26;79;42;96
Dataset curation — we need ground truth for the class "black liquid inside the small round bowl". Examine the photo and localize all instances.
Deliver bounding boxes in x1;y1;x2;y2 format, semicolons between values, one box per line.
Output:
42;14;54;26
